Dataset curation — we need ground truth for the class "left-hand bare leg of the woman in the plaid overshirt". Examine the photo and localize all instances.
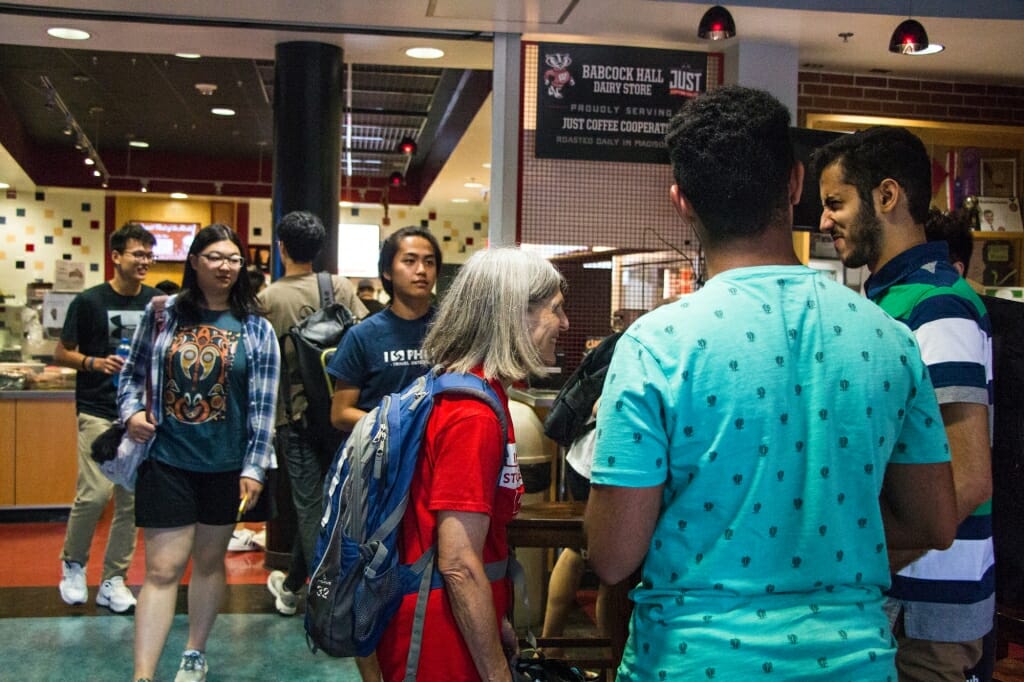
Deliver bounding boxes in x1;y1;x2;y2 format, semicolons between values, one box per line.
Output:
133;525;196;680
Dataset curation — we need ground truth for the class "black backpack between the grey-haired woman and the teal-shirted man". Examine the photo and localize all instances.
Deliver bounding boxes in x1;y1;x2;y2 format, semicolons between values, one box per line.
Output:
544;332;623;447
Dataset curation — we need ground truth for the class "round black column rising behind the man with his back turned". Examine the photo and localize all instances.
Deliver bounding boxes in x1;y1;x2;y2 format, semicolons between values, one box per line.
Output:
271;42;343;270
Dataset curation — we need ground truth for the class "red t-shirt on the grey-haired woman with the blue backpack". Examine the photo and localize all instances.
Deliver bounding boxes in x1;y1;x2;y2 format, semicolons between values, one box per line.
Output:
377;369;523;682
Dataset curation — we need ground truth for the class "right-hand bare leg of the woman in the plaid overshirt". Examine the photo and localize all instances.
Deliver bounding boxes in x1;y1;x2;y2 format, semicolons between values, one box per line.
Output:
185;523;234;651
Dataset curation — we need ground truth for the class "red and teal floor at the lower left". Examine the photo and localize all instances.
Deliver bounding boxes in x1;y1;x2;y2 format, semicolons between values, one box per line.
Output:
0;512;359;682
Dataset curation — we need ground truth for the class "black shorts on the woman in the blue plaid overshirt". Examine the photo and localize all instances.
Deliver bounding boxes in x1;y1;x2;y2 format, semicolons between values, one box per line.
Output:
135;460;271;528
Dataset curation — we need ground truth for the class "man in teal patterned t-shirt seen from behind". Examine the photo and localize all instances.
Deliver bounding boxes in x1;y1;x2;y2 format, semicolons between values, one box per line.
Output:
586;87;955;681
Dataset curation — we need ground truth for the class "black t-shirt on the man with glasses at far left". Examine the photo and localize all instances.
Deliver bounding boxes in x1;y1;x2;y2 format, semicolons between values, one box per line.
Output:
60;282;160;419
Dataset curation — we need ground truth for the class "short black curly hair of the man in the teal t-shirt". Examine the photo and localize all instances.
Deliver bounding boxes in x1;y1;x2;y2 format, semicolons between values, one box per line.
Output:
665;86;796;242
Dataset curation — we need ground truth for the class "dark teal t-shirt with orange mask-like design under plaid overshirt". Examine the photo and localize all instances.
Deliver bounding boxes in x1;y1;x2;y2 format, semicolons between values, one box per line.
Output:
150;310;249;472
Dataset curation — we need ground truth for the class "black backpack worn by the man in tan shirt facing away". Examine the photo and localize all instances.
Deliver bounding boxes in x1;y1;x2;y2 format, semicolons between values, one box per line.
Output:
282;272;356;462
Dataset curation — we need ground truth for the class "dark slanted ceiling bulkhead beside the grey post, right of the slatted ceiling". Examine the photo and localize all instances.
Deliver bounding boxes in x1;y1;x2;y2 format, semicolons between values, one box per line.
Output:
406;69;493;203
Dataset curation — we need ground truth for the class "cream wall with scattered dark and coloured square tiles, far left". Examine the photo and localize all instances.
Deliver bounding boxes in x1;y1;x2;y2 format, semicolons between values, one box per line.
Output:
0;189;106;302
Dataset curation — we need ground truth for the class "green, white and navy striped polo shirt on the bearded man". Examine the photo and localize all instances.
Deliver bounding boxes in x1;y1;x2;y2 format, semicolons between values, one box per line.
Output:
865;242;995;642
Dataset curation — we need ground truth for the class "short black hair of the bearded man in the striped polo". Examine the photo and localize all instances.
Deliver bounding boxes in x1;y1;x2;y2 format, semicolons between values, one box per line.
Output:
811;126;932;223
